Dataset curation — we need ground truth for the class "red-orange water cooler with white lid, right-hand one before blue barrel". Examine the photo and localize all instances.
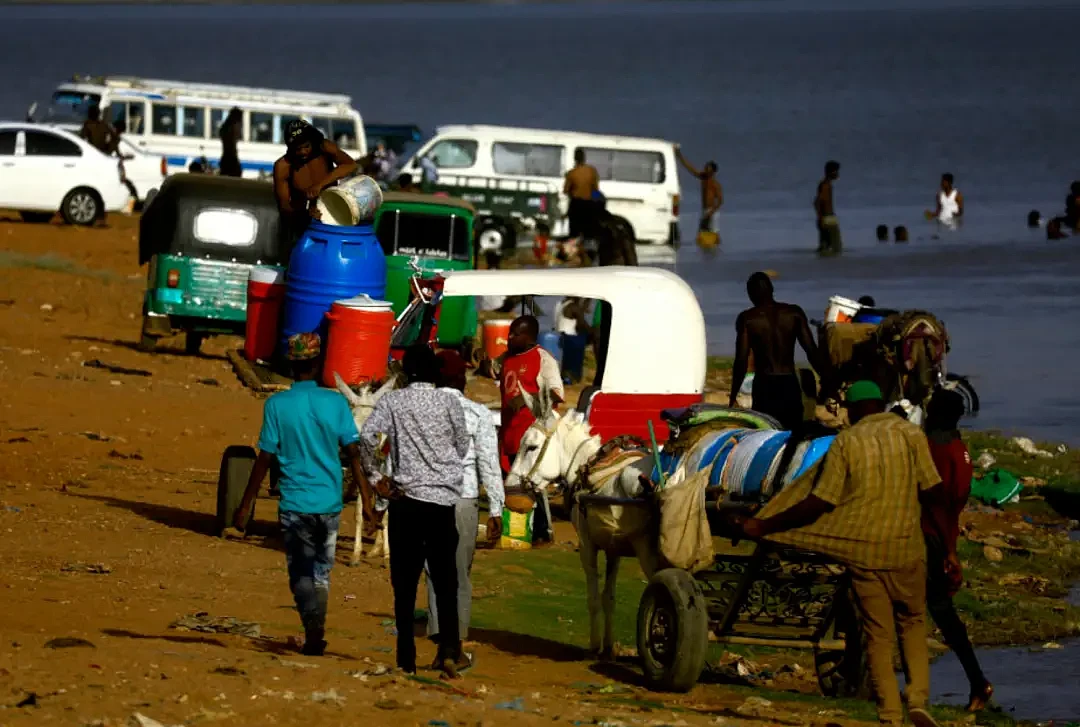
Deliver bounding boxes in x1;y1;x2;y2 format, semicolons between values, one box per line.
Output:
323;295;395;387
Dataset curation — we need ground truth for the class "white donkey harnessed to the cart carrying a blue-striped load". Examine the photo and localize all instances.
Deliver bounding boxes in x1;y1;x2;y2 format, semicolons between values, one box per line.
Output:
507;393;660;660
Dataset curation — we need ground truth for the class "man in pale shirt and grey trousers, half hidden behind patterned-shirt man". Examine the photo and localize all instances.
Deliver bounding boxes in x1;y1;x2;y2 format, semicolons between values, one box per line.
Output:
428;350;503;661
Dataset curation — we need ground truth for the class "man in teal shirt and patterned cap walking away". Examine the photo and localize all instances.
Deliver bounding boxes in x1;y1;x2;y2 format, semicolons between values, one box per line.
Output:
233;333;373;656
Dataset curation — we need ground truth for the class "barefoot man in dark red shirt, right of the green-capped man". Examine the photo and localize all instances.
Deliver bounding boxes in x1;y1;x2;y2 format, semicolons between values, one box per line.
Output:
922;390;994;712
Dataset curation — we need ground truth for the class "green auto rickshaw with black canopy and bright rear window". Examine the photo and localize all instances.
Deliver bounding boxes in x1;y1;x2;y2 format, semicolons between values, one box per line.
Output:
138;174;292;354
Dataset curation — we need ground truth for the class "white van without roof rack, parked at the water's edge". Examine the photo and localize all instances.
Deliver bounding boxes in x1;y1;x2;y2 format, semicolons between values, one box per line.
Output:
402;125;679;249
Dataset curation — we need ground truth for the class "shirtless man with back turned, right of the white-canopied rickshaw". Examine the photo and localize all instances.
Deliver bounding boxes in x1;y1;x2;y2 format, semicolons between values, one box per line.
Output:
728;272;826;429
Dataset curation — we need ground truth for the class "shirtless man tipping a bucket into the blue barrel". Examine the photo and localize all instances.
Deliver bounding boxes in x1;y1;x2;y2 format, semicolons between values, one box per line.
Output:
273;120;356;232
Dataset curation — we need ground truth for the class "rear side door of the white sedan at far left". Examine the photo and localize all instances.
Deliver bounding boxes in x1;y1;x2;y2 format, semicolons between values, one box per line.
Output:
19;129;84;210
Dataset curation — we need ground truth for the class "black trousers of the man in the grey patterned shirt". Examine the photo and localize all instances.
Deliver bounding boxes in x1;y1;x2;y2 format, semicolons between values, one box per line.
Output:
389;497;461;671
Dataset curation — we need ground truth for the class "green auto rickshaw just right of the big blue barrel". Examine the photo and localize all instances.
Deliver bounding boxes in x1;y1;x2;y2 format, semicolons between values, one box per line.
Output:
375;192;476;355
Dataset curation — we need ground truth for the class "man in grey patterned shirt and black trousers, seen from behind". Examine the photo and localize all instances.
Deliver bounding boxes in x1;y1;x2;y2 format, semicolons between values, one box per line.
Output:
360;346;475;678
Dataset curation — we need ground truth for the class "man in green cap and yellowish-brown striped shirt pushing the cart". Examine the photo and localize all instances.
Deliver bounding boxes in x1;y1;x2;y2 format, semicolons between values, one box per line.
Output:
743;381;956;727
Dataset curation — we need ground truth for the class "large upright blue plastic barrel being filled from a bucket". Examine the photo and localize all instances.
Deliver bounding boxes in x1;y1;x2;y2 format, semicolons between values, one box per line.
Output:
281;221;387;348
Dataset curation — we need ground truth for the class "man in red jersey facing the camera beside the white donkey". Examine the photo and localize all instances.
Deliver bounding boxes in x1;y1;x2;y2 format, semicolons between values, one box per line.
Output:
499;315;566;541
